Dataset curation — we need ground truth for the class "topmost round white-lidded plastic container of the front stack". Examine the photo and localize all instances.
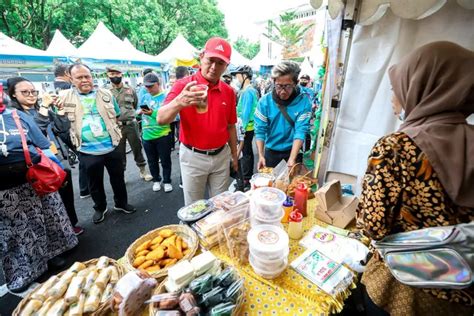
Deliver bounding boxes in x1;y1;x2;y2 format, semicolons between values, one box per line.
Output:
247;225;289;260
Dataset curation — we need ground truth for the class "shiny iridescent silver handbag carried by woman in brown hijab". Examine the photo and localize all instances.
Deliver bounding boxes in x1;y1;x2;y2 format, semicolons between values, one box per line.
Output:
373;221;474;289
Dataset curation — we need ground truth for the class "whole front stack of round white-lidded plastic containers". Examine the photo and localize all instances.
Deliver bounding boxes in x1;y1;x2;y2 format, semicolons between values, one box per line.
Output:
247;225;289;279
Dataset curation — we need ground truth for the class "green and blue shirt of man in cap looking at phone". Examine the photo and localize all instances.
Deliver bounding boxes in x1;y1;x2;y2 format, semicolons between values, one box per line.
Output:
142;92;171;140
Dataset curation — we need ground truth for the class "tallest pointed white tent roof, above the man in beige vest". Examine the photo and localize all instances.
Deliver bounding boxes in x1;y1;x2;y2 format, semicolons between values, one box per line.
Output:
74;22;158;63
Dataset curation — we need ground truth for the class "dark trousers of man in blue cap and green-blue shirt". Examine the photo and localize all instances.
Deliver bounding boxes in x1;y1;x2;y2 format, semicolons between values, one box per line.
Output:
143;134;171;183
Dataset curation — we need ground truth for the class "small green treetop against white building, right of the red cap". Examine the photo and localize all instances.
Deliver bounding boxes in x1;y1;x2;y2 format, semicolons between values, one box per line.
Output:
263;11;313;58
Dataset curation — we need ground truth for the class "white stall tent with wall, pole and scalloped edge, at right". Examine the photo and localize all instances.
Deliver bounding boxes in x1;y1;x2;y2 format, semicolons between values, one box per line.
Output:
311;0;474;190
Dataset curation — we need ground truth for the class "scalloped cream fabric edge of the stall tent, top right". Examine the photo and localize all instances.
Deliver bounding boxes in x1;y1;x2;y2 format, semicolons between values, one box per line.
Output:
310;0;474;25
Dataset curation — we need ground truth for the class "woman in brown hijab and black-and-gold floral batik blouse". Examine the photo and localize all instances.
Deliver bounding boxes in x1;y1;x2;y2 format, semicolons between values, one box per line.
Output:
357;42;474;315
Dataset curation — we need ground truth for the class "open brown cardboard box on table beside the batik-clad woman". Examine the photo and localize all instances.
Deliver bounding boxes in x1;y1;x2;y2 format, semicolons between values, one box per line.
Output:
315;180;359;228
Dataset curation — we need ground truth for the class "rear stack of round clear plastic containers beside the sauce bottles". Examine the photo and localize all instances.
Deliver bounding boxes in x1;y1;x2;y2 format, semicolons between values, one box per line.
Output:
251;188;286;221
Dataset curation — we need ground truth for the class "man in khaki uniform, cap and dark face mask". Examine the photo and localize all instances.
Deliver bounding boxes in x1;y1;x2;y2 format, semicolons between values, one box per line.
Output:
106;66;153;181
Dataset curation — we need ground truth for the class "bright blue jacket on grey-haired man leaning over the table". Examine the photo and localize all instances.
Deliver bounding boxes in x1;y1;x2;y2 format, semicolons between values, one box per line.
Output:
255;93;311;151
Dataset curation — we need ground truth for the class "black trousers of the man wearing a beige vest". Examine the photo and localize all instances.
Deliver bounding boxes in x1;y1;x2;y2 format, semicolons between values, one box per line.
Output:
79;148;128;212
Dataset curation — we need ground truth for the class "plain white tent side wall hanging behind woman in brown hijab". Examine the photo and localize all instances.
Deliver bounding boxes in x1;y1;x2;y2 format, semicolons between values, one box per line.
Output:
327;0;474;191
